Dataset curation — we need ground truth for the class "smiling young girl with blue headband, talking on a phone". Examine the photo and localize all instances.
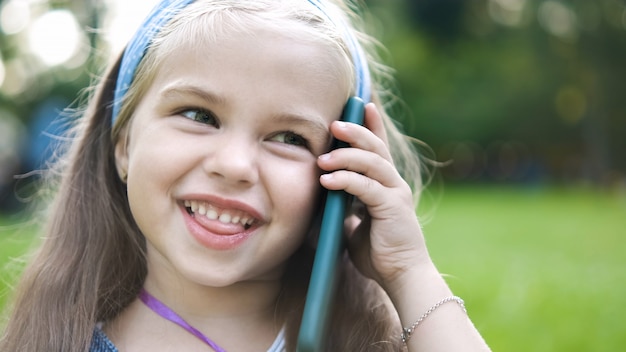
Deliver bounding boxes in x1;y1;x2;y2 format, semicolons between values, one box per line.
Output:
0;0;488;351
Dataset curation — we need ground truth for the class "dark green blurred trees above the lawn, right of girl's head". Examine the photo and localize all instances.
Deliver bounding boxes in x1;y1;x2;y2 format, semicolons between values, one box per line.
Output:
368;0;626;184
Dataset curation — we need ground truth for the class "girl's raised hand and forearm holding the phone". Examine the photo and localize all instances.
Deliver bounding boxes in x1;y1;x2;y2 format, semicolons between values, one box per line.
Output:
318;104;489;351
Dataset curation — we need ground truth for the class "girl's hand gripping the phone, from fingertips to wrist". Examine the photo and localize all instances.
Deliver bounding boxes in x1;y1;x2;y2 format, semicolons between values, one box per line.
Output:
318;103;430;290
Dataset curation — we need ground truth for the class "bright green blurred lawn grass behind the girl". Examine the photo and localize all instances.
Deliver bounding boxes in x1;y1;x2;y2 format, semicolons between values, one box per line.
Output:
0;187;626;352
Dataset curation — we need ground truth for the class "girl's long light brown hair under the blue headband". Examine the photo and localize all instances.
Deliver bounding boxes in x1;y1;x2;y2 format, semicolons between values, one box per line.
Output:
0;0;421;351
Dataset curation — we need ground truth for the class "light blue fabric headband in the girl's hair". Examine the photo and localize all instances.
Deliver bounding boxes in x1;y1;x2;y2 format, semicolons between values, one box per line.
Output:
111;0;371;124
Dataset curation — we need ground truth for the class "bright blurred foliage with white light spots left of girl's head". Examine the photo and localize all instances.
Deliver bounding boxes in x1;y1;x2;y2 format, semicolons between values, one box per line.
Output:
0;0;156;206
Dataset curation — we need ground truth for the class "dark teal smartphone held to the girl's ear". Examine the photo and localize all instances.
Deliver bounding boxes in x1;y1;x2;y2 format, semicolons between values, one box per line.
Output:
296;97;365;352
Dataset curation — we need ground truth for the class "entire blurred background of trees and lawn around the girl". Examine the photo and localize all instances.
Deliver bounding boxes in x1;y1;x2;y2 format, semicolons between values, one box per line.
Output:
0;0;626;351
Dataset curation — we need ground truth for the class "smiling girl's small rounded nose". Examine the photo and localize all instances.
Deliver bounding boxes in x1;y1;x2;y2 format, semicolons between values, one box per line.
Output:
204;135;259;185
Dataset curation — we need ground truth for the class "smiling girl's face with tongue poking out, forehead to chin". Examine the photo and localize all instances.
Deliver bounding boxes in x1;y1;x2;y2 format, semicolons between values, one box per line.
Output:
116;26;349;286
